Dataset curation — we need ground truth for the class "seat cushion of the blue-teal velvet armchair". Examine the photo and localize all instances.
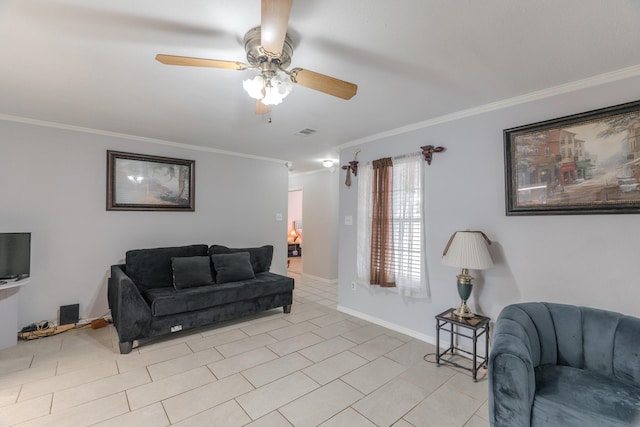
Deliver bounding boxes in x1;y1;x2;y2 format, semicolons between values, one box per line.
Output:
531;365;640;427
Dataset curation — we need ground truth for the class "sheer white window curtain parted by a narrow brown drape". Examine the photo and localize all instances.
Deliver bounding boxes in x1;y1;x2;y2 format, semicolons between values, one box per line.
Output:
357;154;431;298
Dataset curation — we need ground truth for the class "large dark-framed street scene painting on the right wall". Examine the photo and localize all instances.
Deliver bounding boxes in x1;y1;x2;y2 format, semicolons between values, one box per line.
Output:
503;101;640;216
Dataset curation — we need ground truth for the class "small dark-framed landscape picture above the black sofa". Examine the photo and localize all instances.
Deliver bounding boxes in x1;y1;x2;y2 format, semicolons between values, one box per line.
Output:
107;150;195;212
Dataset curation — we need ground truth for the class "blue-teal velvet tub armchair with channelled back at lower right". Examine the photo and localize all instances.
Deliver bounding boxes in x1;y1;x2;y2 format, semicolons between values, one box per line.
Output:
489;303;640;427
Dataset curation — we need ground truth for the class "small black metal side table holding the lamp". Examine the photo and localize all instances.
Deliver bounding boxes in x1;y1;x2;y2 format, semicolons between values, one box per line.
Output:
436;308;491;382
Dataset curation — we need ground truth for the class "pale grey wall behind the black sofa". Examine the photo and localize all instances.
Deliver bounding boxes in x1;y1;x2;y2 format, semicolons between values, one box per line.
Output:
0;120;287;327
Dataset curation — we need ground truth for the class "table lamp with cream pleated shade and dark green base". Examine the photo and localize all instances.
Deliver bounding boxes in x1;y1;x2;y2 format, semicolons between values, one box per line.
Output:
442;231;493;319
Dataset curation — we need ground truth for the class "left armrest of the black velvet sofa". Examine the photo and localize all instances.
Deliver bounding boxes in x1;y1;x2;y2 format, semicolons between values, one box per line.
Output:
107;265;152;353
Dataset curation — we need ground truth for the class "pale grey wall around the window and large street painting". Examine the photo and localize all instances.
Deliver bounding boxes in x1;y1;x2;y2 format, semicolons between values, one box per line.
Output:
339;72;640;339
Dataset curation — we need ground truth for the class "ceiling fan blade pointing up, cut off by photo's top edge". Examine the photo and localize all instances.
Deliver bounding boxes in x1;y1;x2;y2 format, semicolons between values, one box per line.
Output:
260;0;293;56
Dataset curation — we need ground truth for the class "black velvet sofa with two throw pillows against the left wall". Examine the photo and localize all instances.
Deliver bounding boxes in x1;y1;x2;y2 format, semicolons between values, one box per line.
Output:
108;244;294;354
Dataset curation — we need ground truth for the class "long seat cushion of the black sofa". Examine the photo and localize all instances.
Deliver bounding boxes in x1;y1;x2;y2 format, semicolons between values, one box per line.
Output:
143;272;293;317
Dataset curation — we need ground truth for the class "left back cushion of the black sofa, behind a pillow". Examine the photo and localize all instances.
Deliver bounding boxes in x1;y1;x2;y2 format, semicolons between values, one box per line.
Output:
125;245;207;289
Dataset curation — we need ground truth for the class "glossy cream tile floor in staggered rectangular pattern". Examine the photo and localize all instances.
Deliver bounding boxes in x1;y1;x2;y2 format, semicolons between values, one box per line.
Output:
0;274;489;427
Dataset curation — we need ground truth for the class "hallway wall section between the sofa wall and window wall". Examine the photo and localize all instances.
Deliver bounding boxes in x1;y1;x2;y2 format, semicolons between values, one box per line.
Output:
289;169;339;281
